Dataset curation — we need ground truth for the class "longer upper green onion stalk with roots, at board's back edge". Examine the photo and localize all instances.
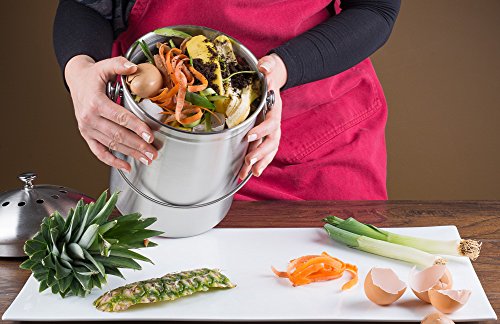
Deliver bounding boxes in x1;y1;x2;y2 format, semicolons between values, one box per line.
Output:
323;216;481;261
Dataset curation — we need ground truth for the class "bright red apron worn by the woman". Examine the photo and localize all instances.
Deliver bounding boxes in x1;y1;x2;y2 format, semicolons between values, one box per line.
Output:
113;0;387;200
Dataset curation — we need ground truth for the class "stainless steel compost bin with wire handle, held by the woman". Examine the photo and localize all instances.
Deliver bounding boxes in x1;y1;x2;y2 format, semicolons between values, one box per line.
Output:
107;25;274;237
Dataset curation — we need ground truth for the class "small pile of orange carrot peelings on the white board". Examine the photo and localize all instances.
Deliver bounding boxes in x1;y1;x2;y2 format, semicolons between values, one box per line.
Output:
271;252;358;290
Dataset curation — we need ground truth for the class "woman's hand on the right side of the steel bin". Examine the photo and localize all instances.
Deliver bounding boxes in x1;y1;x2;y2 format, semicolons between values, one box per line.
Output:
239;54;287;179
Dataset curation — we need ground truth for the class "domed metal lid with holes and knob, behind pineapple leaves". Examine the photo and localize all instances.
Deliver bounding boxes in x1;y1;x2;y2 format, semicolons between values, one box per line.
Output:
0;172;94;257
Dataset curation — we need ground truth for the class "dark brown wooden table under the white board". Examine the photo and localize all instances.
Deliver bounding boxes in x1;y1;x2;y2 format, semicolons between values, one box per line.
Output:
0;201;500;323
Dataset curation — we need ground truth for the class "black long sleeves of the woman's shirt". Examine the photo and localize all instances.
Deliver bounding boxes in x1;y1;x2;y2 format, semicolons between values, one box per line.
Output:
54;0;400;89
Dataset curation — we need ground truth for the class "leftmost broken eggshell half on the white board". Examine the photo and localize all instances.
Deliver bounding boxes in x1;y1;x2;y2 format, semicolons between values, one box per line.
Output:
364;268;406;306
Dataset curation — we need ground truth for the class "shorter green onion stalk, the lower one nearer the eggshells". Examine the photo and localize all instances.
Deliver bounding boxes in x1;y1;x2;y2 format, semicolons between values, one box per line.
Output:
324;224;446;268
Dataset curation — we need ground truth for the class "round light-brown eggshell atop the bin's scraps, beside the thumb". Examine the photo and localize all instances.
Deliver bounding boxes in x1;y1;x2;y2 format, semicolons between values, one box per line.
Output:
126;63;163;98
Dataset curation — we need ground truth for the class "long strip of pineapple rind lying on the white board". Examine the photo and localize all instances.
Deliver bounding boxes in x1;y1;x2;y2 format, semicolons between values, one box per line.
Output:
94;268;236;312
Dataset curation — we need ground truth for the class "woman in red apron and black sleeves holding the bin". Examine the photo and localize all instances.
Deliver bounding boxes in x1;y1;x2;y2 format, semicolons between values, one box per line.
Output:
54;0;400;200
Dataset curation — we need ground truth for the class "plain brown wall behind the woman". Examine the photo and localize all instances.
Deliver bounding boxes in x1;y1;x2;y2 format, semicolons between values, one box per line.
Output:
0;0;500;199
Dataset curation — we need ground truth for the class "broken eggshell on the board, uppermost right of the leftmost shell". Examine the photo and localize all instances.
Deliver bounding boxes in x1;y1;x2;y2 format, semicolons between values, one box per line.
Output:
410;265;453;303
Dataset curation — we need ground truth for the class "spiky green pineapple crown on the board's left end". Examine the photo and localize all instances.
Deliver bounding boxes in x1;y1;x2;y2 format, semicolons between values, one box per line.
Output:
20;191;163;298
